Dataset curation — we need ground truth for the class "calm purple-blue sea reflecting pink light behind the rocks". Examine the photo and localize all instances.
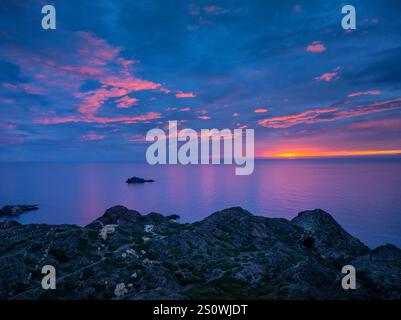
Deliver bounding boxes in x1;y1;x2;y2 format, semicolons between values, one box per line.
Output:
0;159;401;247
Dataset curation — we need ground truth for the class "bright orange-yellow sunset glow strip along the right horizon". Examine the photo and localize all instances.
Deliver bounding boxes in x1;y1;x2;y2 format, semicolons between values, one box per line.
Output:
263;150;401;159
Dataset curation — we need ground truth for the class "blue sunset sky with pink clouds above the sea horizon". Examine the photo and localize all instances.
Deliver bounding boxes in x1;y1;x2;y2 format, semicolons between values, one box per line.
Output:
0;0;401;162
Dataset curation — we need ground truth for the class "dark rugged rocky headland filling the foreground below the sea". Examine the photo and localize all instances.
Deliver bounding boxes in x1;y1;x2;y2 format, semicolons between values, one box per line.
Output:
0;206;401;299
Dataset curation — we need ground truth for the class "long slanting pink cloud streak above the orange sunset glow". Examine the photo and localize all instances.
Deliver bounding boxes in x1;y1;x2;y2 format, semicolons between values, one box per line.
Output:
258;98;401;129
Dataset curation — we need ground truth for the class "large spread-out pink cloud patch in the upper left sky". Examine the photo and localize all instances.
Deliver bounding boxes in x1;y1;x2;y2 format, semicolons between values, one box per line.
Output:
0;32;181;119
